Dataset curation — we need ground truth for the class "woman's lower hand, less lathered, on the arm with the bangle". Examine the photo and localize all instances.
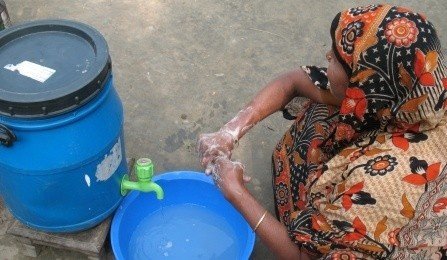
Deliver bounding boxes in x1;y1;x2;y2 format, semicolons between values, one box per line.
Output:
211;157;251;201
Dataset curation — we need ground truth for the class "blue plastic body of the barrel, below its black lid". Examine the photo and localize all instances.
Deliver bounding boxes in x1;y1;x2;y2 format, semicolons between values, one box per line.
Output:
0;77;127;232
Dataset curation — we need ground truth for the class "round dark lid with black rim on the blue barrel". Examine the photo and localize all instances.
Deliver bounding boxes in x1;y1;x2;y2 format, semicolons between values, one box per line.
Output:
0;20;111;118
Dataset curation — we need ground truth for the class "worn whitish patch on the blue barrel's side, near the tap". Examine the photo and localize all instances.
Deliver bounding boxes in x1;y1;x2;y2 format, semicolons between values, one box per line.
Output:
95;138;123;181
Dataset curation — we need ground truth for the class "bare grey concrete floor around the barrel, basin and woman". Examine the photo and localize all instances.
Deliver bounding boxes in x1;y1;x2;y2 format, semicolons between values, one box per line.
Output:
0;0;447;259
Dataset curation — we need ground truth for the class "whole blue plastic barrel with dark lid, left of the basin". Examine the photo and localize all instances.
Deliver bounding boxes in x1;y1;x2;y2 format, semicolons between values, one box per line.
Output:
0;20;127;232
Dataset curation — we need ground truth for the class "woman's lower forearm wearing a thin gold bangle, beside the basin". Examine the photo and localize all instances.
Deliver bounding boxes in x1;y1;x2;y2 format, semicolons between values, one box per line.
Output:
230;188;308;259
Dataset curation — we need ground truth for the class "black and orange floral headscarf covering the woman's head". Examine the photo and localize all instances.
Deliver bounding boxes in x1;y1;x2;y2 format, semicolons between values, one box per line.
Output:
331;5;447;153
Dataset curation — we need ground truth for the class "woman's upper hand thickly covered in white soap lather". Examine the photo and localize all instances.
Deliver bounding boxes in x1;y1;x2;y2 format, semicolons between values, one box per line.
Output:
197;130;237;175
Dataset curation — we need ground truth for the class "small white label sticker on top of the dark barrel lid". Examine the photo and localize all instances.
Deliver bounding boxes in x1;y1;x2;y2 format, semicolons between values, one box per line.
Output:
4;60;56;83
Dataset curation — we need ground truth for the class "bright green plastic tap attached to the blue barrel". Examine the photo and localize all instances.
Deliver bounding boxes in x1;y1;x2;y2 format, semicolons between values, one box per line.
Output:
121;158;164;200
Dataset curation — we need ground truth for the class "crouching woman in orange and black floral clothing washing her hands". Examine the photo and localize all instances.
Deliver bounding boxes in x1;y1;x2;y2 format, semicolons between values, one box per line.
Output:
198;5;447;259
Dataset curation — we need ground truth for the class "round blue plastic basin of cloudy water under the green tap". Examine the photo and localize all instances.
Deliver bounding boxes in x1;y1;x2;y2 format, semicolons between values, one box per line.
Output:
111;171;255;260
